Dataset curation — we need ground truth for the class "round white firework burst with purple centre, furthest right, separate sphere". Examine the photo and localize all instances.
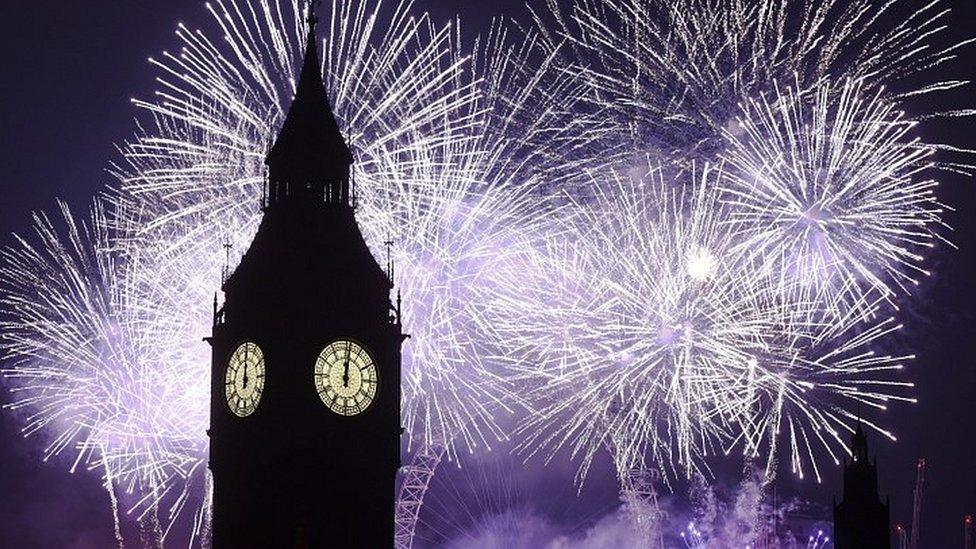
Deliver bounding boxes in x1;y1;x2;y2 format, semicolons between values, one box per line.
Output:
723;82;945;319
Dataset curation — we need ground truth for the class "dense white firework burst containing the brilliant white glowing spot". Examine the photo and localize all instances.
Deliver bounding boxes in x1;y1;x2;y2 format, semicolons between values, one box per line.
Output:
496;155;789;484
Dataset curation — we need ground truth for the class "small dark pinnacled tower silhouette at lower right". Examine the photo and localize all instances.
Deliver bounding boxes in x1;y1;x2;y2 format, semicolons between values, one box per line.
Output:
834;421;891;549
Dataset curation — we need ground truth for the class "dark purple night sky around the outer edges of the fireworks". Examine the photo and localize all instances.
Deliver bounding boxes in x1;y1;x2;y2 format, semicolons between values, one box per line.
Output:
0;0;976;548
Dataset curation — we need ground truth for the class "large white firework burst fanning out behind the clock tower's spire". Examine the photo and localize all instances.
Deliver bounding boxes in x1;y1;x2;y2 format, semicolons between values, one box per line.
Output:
117;2;492;464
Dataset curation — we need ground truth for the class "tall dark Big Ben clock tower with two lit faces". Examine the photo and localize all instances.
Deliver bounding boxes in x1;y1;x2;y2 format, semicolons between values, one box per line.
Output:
209;3;403;549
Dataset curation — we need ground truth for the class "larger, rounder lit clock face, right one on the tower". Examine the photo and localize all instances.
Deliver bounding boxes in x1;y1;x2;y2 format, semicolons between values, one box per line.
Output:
315;339;379;416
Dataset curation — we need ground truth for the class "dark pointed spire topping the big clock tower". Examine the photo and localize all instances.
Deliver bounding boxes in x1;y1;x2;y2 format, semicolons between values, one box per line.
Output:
265;0;352;207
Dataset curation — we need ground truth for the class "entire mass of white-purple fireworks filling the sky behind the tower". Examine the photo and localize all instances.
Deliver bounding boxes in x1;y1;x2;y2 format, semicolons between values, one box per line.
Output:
0;0;976;547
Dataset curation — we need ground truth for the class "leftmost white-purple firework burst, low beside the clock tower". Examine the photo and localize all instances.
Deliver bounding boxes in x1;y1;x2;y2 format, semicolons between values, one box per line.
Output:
0;199;203;536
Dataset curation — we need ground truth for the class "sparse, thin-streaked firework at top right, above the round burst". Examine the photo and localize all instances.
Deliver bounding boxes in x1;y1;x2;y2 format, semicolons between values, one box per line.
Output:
535;0;974;159
